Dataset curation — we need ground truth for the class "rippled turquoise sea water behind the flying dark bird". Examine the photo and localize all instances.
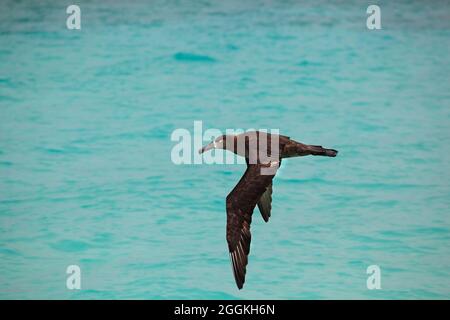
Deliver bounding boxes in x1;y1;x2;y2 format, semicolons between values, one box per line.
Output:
0;0;450;299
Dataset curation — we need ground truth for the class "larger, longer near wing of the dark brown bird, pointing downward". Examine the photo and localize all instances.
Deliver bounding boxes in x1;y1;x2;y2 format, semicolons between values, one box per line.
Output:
227;162;278;289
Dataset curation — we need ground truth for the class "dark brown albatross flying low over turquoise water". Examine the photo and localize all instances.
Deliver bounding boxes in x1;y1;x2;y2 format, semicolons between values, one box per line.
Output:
199;131;338;290
